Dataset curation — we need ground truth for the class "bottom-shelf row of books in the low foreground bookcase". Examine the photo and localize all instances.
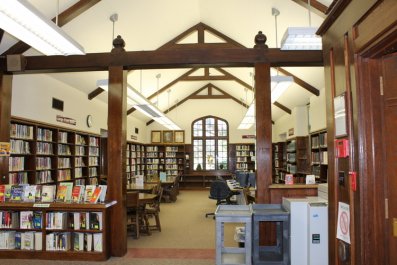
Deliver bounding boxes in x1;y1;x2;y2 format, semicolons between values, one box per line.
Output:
0;231;103;252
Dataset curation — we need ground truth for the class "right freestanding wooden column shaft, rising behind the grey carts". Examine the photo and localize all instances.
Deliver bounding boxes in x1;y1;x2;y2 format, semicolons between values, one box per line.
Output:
255;63;272;203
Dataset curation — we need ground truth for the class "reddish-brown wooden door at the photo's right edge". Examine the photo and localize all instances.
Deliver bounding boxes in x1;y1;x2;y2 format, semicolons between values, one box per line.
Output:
382;53;397;264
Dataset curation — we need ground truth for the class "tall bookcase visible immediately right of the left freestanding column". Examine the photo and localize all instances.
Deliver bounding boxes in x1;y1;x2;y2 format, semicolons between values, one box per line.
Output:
126;142;146;182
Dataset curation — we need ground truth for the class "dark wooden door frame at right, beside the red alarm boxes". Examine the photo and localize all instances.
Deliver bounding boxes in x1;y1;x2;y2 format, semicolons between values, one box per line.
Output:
355;29;397;264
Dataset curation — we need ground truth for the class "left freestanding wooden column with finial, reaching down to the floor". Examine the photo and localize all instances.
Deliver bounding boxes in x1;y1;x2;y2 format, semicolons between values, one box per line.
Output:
107;35;127;257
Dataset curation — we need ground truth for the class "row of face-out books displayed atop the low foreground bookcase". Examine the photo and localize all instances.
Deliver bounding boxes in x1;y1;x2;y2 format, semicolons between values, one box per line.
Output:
0;182;107;203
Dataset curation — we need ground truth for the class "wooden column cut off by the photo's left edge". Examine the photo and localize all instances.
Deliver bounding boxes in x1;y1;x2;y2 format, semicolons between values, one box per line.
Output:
0;73;12;184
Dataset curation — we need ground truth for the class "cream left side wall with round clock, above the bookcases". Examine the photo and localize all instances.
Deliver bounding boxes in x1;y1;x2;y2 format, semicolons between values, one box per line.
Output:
11;74;146;139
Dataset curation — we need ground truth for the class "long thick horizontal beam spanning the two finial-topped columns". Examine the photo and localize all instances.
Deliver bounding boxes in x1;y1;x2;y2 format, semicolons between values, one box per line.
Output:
0;48;324;74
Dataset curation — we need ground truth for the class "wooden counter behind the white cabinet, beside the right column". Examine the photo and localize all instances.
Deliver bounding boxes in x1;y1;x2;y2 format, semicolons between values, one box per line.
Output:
269;184;317;203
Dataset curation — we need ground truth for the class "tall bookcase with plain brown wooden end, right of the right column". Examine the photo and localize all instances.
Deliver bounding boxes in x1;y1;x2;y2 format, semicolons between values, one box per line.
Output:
286;136;311;183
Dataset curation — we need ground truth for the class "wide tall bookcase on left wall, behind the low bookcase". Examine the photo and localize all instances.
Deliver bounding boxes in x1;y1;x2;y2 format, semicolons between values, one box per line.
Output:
6;119;101;185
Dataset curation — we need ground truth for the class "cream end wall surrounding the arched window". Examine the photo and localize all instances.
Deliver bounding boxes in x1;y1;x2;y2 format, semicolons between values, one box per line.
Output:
147;99;255;144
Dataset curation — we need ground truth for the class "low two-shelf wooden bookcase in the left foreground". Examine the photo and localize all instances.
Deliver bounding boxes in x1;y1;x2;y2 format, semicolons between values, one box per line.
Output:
0;201;116;261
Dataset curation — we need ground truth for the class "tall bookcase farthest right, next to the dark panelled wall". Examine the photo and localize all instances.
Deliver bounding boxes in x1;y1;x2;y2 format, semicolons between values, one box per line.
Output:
310;131;328;183
